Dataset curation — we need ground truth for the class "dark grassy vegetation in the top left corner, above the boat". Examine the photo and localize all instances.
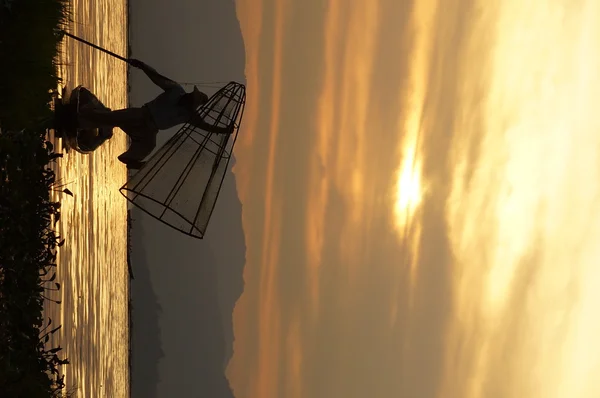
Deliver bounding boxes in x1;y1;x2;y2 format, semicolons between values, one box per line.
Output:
0;0;71;131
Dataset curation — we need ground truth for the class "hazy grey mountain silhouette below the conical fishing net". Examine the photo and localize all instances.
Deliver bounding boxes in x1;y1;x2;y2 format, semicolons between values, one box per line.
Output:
132;182;244;398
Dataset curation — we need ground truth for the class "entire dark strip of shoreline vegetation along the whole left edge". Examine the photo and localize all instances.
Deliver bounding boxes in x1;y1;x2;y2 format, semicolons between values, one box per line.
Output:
0;0;70;398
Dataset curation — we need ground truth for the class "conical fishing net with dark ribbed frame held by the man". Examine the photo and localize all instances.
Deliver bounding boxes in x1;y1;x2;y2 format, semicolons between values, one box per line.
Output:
120;82;246;239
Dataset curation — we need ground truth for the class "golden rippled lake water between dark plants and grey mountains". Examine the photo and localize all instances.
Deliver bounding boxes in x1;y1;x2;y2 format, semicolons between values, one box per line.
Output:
46;0;130;398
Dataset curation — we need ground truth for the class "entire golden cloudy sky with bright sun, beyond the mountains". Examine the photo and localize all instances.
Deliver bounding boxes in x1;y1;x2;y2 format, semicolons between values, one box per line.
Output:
227;0;600;398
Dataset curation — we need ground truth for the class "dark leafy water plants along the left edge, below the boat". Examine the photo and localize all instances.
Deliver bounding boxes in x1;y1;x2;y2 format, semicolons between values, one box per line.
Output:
0;130;69;398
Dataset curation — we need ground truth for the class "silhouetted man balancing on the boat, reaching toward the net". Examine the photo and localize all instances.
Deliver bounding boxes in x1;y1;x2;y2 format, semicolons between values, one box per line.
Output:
78;59;229;169
